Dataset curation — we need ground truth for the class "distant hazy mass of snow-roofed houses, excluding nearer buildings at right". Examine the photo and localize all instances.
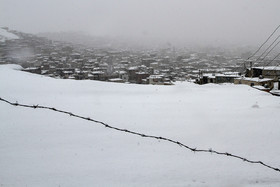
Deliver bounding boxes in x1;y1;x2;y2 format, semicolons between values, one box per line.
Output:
0;28;243;85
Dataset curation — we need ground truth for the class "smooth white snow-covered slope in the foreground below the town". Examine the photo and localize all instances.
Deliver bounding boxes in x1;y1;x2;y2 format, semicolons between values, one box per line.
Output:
0;65;280;187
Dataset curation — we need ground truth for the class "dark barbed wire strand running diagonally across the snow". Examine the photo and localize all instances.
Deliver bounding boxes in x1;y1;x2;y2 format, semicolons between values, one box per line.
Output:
0;97;280;172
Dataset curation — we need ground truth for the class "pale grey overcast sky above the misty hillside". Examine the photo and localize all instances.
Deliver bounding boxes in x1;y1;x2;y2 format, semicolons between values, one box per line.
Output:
0;0;280;45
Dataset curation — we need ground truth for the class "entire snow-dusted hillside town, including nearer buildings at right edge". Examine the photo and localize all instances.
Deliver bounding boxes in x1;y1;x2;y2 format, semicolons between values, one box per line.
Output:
0;28;280;91
